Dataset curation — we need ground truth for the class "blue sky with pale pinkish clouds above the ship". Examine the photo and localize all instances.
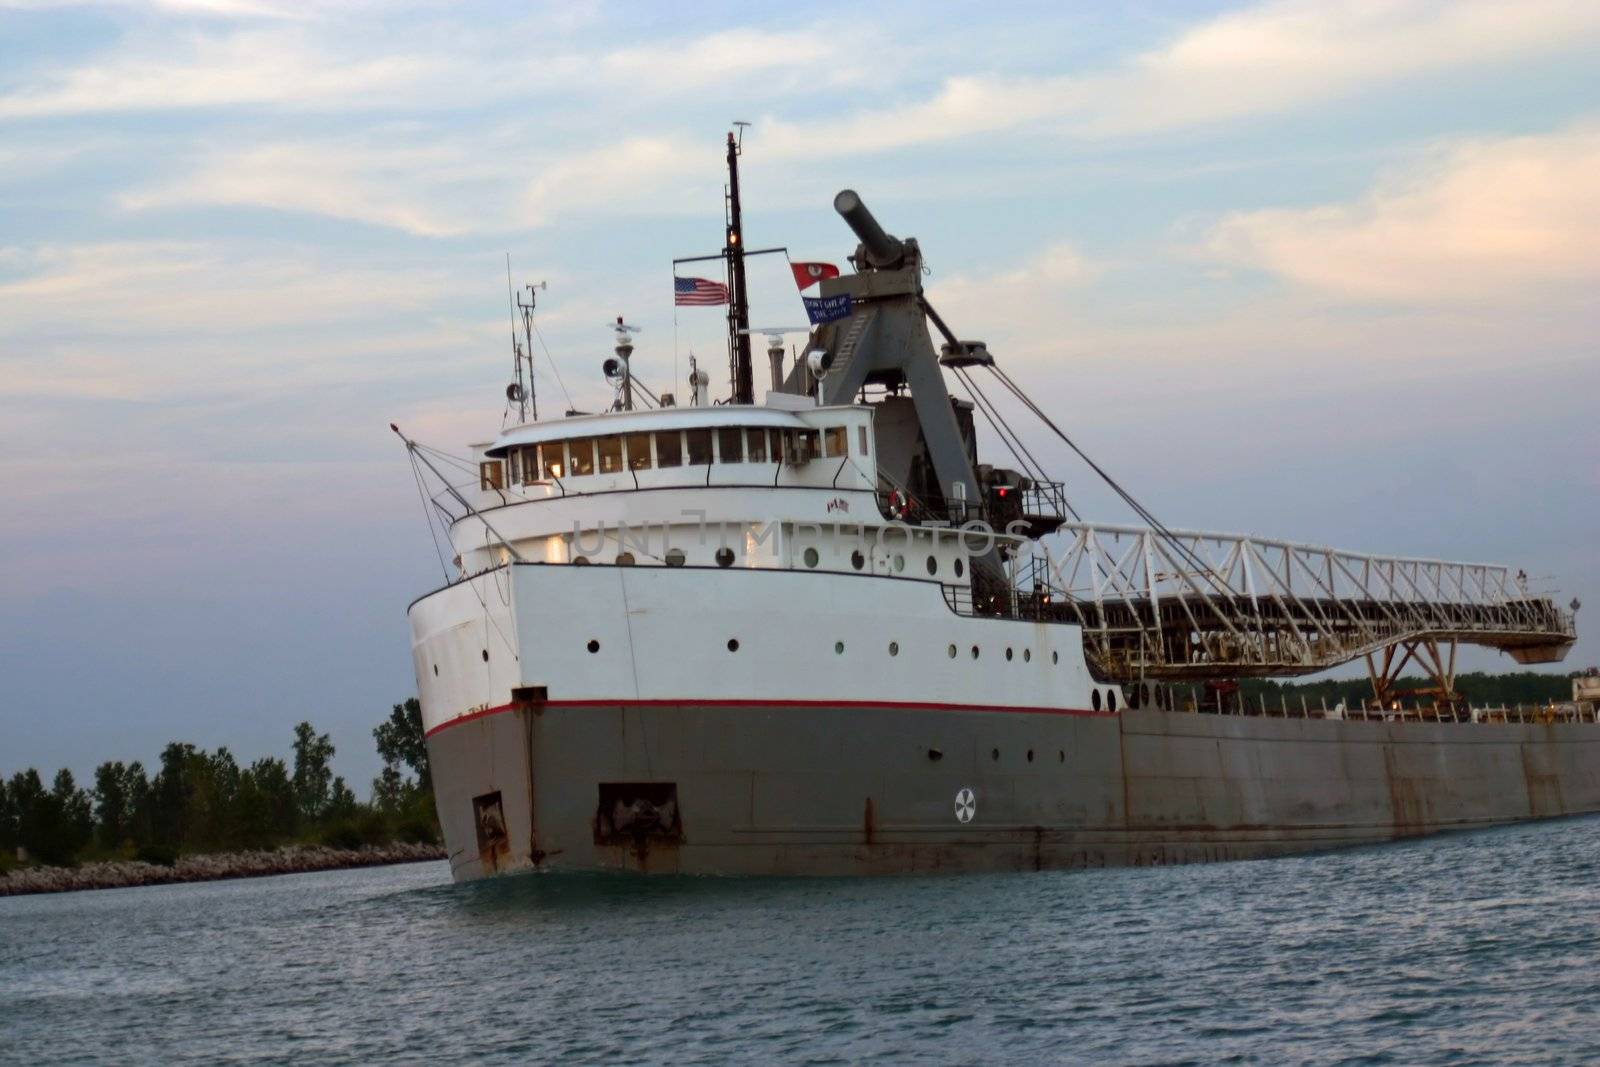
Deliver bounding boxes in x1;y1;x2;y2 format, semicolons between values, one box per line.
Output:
0;0;1600;793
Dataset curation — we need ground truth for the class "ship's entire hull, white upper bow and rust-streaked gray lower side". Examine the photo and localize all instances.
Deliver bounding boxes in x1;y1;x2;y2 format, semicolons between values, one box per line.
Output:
411;565;1600;880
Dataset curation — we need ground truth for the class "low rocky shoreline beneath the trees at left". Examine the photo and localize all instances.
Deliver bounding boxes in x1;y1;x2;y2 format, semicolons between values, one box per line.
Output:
0;843;445;896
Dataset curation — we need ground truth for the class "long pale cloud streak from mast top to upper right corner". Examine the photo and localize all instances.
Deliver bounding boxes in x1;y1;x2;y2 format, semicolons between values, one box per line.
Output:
763;0;1600;154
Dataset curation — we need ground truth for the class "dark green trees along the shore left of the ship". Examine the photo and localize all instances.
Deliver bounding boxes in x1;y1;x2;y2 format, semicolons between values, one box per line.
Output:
0;697;438;864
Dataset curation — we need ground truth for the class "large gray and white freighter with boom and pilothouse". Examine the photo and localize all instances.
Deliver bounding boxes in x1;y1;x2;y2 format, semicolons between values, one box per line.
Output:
406;136;1600;880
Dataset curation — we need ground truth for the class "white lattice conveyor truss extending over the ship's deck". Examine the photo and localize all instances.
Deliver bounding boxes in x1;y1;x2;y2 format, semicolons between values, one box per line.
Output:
992;522;1576;702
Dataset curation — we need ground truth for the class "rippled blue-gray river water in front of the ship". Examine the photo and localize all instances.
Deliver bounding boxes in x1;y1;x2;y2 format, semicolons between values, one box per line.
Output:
0;817;1600;1064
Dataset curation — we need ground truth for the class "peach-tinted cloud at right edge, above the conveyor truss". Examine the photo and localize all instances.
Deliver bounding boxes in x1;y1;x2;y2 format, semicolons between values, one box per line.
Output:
1205;125;1600;301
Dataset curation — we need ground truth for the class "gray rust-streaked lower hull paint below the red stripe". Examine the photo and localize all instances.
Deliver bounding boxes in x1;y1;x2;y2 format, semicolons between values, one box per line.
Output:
429;705;1600;880
